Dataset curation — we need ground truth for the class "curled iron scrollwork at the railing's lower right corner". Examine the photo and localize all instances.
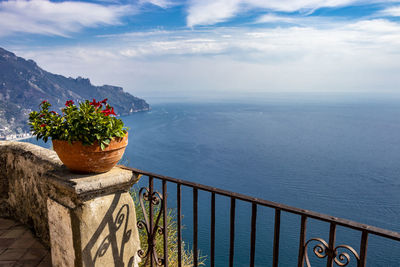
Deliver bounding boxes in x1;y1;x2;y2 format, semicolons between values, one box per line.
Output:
304;238;360;267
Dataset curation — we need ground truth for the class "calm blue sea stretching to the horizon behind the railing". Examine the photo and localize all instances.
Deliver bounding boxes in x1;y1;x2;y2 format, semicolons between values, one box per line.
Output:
24;100;400;266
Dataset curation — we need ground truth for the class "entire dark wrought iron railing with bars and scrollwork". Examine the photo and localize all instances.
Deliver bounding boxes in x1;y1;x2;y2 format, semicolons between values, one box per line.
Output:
120;166;400;267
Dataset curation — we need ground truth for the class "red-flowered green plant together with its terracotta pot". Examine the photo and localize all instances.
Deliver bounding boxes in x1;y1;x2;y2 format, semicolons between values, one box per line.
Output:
29;99;128;173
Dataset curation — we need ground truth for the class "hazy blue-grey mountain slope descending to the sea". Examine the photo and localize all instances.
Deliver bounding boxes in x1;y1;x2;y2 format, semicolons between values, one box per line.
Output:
0;47;150;136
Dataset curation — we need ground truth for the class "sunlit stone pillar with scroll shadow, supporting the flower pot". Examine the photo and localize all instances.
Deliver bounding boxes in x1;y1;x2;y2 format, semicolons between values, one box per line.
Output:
47;167;140;266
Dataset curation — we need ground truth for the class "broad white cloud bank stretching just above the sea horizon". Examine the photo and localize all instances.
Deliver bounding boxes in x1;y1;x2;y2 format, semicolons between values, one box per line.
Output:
6;19;400;96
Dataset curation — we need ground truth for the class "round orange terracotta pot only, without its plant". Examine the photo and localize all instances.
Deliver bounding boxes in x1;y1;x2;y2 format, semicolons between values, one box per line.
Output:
52;133;128;173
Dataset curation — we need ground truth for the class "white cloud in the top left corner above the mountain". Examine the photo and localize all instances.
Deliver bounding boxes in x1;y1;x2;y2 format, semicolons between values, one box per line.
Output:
0;0;134;36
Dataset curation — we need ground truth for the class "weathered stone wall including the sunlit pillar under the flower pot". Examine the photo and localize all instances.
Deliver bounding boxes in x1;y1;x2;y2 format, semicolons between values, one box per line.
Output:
0;141;140;266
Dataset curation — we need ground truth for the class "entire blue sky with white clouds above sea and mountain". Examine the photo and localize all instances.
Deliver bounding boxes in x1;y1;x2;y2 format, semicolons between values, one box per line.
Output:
0;0;400;97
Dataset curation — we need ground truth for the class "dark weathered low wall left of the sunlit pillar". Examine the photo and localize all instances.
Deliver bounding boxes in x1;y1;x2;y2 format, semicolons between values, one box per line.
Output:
0;141;62;246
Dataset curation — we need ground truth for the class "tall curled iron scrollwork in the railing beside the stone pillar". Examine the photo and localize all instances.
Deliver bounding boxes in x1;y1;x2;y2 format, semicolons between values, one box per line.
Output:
137;187;164;266
